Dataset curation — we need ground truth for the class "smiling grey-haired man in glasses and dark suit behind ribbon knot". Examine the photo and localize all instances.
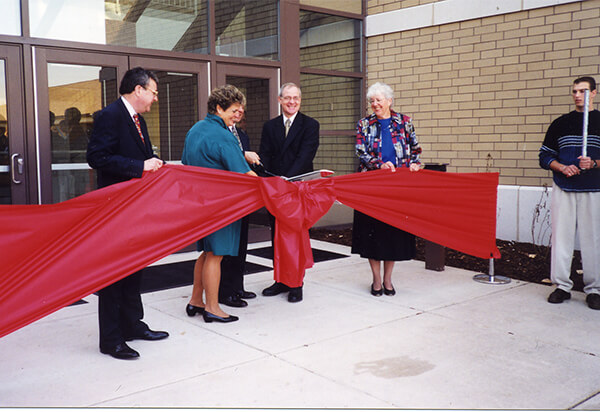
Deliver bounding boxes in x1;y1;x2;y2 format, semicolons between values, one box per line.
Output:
259;83;319;302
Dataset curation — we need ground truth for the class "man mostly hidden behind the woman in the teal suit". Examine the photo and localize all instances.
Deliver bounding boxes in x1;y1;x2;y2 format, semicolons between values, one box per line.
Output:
219;108;260;308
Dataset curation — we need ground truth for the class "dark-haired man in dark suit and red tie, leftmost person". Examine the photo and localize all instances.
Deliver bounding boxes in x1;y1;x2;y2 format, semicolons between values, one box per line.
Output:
87;67;169;359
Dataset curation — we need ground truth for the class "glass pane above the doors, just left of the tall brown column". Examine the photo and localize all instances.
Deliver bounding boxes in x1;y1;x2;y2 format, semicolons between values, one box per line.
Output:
215;0;279;60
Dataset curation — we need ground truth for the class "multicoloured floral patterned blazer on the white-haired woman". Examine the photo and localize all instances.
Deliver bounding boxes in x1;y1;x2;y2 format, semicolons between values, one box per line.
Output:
356;111;421;172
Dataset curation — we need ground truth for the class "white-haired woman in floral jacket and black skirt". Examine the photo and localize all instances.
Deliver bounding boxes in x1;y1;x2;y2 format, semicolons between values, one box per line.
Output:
352;83;421;296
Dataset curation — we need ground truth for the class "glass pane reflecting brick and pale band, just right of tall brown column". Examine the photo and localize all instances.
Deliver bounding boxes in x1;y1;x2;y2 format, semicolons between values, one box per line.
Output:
300;10;362;72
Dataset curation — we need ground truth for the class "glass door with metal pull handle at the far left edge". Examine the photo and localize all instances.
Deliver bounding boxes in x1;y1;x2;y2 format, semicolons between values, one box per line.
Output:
0;45;28;205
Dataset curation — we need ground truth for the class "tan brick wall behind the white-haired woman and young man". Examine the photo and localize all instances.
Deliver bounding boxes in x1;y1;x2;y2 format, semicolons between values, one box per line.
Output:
367;0;600;186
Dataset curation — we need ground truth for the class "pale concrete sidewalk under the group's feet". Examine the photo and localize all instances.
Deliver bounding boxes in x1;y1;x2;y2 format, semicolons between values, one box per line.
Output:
0;240;600;409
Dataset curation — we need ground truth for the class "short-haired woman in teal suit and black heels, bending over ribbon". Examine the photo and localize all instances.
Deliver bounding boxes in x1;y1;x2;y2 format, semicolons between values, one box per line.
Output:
181;85;256;322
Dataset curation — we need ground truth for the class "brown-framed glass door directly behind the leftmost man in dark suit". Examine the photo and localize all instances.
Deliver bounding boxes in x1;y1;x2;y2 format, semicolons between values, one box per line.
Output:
35;49;127;203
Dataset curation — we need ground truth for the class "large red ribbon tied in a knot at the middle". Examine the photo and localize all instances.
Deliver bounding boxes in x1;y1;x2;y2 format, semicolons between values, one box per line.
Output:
0;165;499;337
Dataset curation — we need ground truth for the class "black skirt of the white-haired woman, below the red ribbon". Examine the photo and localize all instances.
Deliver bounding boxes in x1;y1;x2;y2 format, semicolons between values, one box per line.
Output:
352;210;416;261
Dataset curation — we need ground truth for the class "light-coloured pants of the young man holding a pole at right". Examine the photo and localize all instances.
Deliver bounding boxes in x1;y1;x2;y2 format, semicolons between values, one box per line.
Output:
550;184;600;294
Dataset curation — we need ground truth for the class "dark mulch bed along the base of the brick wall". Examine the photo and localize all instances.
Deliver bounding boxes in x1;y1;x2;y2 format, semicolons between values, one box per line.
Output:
310;227;583;291
